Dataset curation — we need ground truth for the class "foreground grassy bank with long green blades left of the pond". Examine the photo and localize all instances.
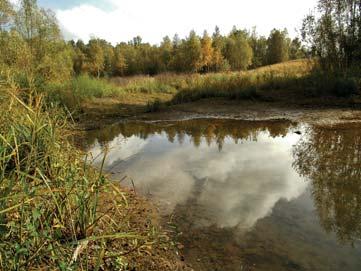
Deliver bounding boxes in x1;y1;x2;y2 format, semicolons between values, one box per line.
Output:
0;79;184;270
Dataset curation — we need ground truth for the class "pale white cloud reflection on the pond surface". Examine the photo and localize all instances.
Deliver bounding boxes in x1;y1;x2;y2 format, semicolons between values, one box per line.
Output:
91;127;307;230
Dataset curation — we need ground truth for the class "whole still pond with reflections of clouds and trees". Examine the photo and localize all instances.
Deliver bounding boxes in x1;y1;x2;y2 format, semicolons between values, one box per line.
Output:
86;119;361;270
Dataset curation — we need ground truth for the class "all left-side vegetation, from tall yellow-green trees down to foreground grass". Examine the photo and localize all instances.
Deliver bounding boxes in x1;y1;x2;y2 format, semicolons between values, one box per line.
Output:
0;0;183;270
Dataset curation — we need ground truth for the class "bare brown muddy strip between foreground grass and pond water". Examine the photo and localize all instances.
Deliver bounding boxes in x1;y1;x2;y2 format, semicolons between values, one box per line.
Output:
100;187;192;271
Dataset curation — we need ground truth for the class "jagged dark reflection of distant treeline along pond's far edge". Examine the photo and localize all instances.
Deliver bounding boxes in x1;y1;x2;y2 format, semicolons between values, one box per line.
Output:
83;119;296;150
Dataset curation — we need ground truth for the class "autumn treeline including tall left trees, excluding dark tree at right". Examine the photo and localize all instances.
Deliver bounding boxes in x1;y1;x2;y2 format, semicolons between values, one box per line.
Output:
0;0;306;81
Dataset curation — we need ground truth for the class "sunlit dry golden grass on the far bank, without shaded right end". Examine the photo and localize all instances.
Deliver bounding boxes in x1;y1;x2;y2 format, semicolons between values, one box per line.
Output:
58;60;314;118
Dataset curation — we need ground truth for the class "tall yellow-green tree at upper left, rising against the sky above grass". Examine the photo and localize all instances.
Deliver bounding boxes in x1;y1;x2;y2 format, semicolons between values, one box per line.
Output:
2;0;72;84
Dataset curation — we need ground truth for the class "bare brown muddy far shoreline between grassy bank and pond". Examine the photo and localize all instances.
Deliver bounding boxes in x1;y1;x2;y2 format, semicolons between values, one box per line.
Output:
77;99;361;131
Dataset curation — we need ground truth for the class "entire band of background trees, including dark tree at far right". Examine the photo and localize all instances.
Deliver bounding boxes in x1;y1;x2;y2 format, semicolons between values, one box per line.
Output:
0;0;361;85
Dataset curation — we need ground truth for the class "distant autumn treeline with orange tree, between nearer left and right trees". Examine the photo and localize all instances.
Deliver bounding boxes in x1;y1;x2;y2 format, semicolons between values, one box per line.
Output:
69;27;307;76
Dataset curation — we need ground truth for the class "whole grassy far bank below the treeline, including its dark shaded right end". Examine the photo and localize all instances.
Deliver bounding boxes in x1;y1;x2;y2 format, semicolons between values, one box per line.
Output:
47;60;360;120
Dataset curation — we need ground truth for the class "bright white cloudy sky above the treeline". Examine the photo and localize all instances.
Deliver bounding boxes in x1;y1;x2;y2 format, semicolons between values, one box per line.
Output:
22;0;317;44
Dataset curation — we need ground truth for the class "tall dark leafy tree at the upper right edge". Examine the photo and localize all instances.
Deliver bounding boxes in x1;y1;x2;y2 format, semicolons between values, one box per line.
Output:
302;0;361;72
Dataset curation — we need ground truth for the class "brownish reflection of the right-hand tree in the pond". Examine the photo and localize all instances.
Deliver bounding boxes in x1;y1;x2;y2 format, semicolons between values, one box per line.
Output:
293;124;361;242
